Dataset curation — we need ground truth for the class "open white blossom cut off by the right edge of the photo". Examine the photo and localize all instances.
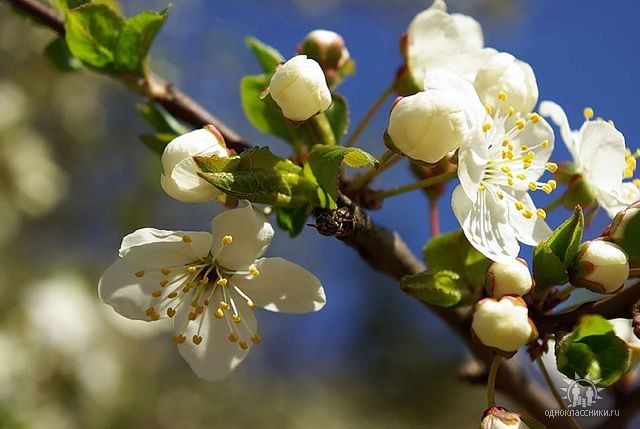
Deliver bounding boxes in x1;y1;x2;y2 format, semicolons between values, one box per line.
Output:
540;101;640;218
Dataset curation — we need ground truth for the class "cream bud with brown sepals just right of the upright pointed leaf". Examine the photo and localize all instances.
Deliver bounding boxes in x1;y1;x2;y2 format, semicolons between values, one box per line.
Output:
569;240;629;293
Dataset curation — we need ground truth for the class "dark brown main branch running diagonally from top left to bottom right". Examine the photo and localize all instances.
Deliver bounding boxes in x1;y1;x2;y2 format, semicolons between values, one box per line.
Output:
4;0;560;427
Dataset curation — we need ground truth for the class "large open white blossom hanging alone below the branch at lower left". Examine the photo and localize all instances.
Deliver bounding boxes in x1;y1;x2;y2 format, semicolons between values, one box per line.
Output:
99;203;325;380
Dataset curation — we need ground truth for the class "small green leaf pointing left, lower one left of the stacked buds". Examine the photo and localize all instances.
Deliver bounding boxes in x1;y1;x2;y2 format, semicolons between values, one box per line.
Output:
400;270;470;307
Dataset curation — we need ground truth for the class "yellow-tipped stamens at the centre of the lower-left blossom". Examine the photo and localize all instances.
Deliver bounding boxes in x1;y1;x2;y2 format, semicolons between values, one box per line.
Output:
135;234;262;350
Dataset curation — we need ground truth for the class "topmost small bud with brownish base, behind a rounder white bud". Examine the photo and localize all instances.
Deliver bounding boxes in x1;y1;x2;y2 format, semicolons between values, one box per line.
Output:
298;30;353;85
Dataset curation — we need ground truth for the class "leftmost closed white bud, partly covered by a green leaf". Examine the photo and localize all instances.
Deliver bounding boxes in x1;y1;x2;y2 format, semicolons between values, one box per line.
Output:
160;125;229;203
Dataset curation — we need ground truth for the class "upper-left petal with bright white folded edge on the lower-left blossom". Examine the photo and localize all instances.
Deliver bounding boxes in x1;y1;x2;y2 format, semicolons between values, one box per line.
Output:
119;228;211;268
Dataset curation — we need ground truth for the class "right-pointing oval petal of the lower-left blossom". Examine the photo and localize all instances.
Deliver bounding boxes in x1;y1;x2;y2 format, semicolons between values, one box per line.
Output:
232;258;326;313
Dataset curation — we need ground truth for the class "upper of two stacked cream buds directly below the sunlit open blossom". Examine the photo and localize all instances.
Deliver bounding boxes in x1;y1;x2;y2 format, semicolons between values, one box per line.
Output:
486;258;533;298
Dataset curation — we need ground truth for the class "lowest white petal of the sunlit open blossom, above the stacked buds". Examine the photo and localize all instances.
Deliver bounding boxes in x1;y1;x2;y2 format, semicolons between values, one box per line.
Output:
451;186;520;263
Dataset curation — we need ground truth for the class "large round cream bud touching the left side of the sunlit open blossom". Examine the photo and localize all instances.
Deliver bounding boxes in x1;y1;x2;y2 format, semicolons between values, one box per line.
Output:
388;89;470;163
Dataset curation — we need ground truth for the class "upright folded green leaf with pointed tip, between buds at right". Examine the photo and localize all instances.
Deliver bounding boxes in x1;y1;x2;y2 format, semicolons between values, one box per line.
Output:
533;206;584;290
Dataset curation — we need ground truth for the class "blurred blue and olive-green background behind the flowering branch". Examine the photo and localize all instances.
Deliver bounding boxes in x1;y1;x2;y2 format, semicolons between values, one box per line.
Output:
0;0;640;429
